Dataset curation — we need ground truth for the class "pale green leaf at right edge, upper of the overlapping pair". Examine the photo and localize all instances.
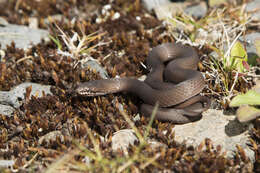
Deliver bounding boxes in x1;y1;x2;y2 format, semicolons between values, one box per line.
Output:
229;90;260;107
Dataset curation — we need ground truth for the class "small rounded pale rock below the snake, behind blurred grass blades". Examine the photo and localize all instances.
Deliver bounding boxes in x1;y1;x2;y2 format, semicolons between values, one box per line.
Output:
112;129;138;155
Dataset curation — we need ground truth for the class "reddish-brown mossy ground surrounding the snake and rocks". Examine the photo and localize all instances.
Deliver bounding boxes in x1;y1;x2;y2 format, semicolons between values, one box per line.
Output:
0;0;260;172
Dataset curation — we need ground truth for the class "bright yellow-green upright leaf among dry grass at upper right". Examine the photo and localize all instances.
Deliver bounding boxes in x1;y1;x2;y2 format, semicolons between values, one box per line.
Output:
230;41;247;72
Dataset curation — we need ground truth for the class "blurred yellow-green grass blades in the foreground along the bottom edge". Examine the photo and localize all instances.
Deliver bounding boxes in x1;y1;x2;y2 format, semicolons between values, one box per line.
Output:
45;104;159;173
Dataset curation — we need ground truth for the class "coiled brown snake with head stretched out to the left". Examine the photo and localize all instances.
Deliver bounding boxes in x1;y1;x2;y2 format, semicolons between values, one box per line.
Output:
74;42;210;124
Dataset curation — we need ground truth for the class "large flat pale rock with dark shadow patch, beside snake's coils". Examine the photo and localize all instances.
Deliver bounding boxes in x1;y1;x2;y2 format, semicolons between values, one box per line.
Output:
173;109;255;162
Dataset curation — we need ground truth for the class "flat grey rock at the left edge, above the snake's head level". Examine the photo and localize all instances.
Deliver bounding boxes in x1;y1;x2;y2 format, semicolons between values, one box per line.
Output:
0;24;50;50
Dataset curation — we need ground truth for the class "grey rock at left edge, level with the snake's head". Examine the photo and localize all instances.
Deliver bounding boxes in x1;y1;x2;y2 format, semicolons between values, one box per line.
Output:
0;82;52;108
